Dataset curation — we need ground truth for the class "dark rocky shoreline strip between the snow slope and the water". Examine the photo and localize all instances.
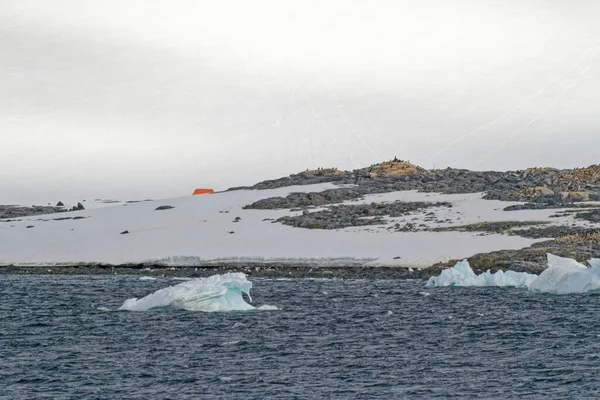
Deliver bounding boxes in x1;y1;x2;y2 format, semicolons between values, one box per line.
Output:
0;233;600;280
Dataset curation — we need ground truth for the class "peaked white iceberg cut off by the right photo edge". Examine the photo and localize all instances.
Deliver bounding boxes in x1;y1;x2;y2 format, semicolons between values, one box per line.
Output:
529;254;600;294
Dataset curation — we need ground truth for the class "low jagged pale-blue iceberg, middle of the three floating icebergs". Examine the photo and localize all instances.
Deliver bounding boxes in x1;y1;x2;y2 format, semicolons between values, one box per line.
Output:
425;260;538;287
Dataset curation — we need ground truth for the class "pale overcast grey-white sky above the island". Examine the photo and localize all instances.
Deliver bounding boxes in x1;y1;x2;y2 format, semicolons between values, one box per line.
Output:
0;0;600;204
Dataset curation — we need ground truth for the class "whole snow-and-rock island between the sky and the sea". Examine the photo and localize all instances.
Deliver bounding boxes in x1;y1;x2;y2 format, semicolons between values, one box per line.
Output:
0;159;600;278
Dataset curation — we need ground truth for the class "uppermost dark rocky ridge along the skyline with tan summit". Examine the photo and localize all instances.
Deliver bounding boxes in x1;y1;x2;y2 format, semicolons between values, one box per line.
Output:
237;159;600;208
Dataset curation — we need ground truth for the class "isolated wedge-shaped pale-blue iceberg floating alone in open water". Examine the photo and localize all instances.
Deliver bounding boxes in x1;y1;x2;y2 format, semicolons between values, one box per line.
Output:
119;272;277;312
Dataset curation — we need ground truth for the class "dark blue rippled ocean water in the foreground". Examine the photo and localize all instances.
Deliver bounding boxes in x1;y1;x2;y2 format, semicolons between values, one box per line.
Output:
0;276;600;399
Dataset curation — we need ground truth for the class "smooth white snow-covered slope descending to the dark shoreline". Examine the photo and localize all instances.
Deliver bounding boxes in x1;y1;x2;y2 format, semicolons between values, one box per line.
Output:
0;184;550;267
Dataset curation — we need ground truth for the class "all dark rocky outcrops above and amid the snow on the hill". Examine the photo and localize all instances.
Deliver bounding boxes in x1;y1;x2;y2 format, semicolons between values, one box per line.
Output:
244;159;600;238
